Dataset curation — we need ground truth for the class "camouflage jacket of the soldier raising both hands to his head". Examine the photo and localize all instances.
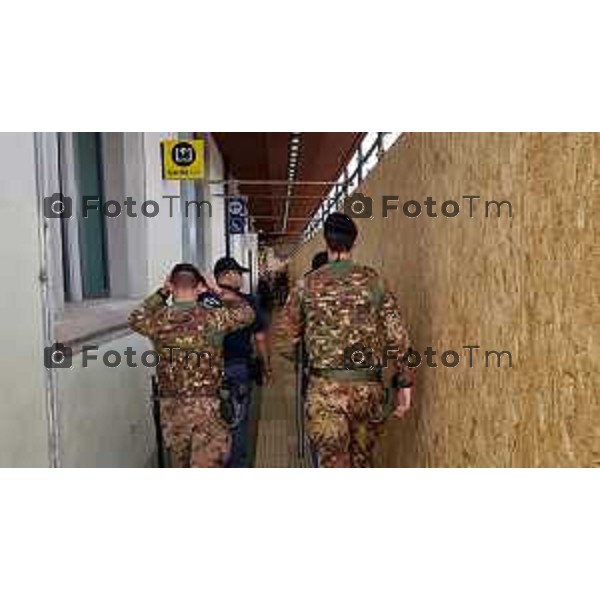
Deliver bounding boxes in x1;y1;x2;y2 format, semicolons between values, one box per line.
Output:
129;292;254;397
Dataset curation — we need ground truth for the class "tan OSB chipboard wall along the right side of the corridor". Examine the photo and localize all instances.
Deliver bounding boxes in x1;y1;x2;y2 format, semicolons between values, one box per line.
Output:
291;133;600;466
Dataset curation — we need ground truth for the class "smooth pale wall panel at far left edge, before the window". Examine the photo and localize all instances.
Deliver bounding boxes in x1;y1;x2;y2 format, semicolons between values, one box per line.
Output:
0;133;49;466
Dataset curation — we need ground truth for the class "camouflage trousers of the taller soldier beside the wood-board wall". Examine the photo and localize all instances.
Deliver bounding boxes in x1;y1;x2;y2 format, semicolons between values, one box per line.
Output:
306;377;383;467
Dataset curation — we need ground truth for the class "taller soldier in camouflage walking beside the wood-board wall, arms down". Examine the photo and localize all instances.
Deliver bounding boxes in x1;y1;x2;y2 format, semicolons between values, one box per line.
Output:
285;213;414;467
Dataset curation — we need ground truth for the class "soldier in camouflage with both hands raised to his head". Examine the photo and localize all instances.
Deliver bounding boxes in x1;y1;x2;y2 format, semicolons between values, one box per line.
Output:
129;264;254;467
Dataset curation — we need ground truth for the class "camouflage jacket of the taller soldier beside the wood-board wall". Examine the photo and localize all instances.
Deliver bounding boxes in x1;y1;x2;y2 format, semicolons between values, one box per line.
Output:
285;260;414;384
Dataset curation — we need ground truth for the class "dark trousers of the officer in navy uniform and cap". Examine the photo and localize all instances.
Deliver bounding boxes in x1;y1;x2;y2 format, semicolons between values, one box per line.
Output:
225;361;253;469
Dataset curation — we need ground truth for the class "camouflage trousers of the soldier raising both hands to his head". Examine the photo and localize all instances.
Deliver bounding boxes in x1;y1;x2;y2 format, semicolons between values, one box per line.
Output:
160;396;231;467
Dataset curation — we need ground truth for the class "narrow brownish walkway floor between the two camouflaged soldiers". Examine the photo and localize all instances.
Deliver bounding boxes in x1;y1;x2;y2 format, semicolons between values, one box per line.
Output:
255;311;306;467
